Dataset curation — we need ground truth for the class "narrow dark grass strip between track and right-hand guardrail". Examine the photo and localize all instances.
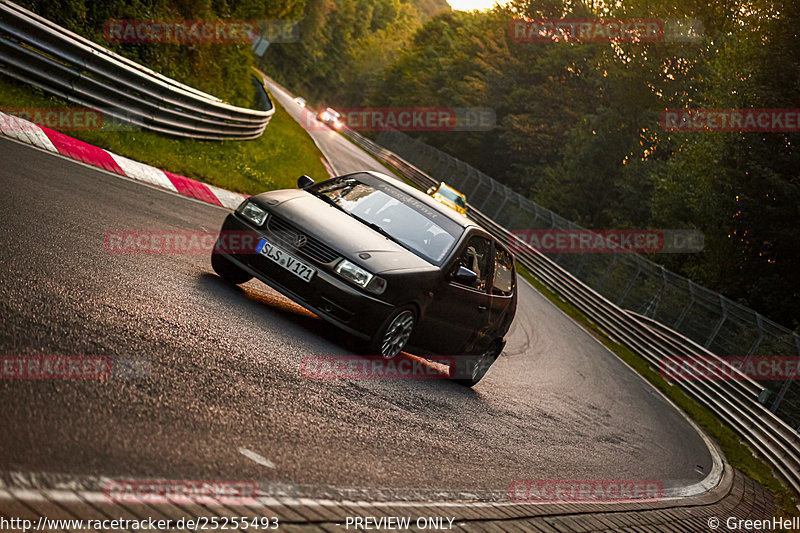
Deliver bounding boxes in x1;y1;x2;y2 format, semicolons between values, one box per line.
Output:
517;263;800;516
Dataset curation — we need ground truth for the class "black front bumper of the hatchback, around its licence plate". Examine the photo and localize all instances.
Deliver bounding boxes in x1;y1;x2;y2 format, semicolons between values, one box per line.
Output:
214;214;394;339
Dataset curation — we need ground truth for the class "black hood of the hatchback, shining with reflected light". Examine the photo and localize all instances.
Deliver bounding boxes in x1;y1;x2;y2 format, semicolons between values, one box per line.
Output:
253;190;436;274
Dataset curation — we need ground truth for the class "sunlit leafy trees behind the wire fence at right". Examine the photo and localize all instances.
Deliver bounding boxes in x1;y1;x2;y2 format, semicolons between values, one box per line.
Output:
267;0;800;327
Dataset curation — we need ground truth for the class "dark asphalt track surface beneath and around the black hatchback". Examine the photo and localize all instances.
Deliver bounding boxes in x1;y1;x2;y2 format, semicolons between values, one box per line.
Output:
0;129;711;500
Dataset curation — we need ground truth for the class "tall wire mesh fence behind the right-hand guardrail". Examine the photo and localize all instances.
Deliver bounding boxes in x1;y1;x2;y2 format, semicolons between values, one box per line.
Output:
376;131;800;431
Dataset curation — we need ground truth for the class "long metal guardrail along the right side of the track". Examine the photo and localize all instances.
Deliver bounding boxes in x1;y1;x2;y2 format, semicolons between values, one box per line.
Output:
345;130;800;493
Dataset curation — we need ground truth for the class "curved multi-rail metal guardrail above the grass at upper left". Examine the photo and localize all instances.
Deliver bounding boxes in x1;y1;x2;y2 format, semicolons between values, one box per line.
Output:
0;0;275;140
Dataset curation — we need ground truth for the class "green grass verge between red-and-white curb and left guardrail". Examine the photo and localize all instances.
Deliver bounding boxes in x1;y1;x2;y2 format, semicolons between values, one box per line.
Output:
0;77;328;194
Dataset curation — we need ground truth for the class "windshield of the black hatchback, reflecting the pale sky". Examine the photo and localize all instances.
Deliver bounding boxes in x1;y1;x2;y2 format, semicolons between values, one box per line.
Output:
311;174;464;265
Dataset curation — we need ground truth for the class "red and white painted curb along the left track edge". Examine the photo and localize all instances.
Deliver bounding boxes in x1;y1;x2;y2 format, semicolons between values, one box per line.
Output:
0;112;247;209
